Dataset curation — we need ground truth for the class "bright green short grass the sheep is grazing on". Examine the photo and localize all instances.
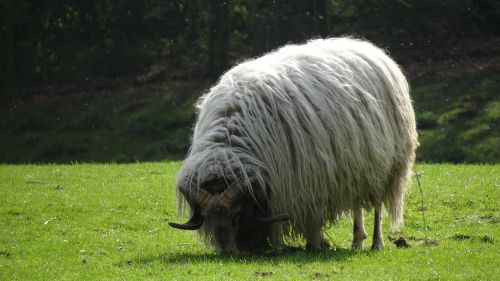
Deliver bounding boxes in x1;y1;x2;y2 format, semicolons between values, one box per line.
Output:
0;162;500;280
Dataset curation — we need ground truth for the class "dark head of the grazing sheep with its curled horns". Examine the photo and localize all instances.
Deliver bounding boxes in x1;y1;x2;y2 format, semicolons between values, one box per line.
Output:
169;179;289;255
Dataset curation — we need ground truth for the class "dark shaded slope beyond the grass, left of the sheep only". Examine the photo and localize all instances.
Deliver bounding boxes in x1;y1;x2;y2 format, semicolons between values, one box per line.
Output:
0;81;209;163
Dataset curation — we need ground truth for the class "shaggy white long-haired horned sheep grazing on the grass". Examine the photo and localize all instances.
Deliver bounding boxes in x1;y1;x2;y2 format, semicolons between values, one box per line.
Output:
170;38;418;254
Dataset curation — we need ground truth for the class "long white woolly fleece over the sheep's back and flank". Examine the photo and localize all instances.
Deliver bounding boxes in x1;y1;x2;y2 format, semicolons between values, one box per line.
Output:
192;38;416;233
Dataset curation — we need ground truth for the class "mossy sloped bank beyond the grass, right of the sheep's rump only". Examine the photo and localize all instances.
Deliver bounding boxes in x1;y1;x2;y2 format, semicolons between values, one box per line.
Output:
413;71;500;163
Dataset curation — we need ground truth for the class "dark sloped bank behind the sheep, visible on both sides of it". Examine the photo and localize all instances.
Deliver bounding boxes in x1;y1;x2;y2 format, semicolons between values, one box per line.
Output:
0;39;500;163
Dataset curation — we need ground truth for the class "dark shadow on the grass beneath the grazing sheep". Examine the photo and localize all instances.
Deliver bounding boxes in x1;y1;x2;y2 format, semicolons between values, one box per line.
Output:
118;248;374;265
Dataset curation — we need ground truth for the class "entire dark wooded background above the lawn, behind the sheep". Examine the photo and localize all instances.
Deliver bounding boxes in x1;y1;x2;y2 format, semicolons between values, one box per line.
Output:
0;0;500;163
